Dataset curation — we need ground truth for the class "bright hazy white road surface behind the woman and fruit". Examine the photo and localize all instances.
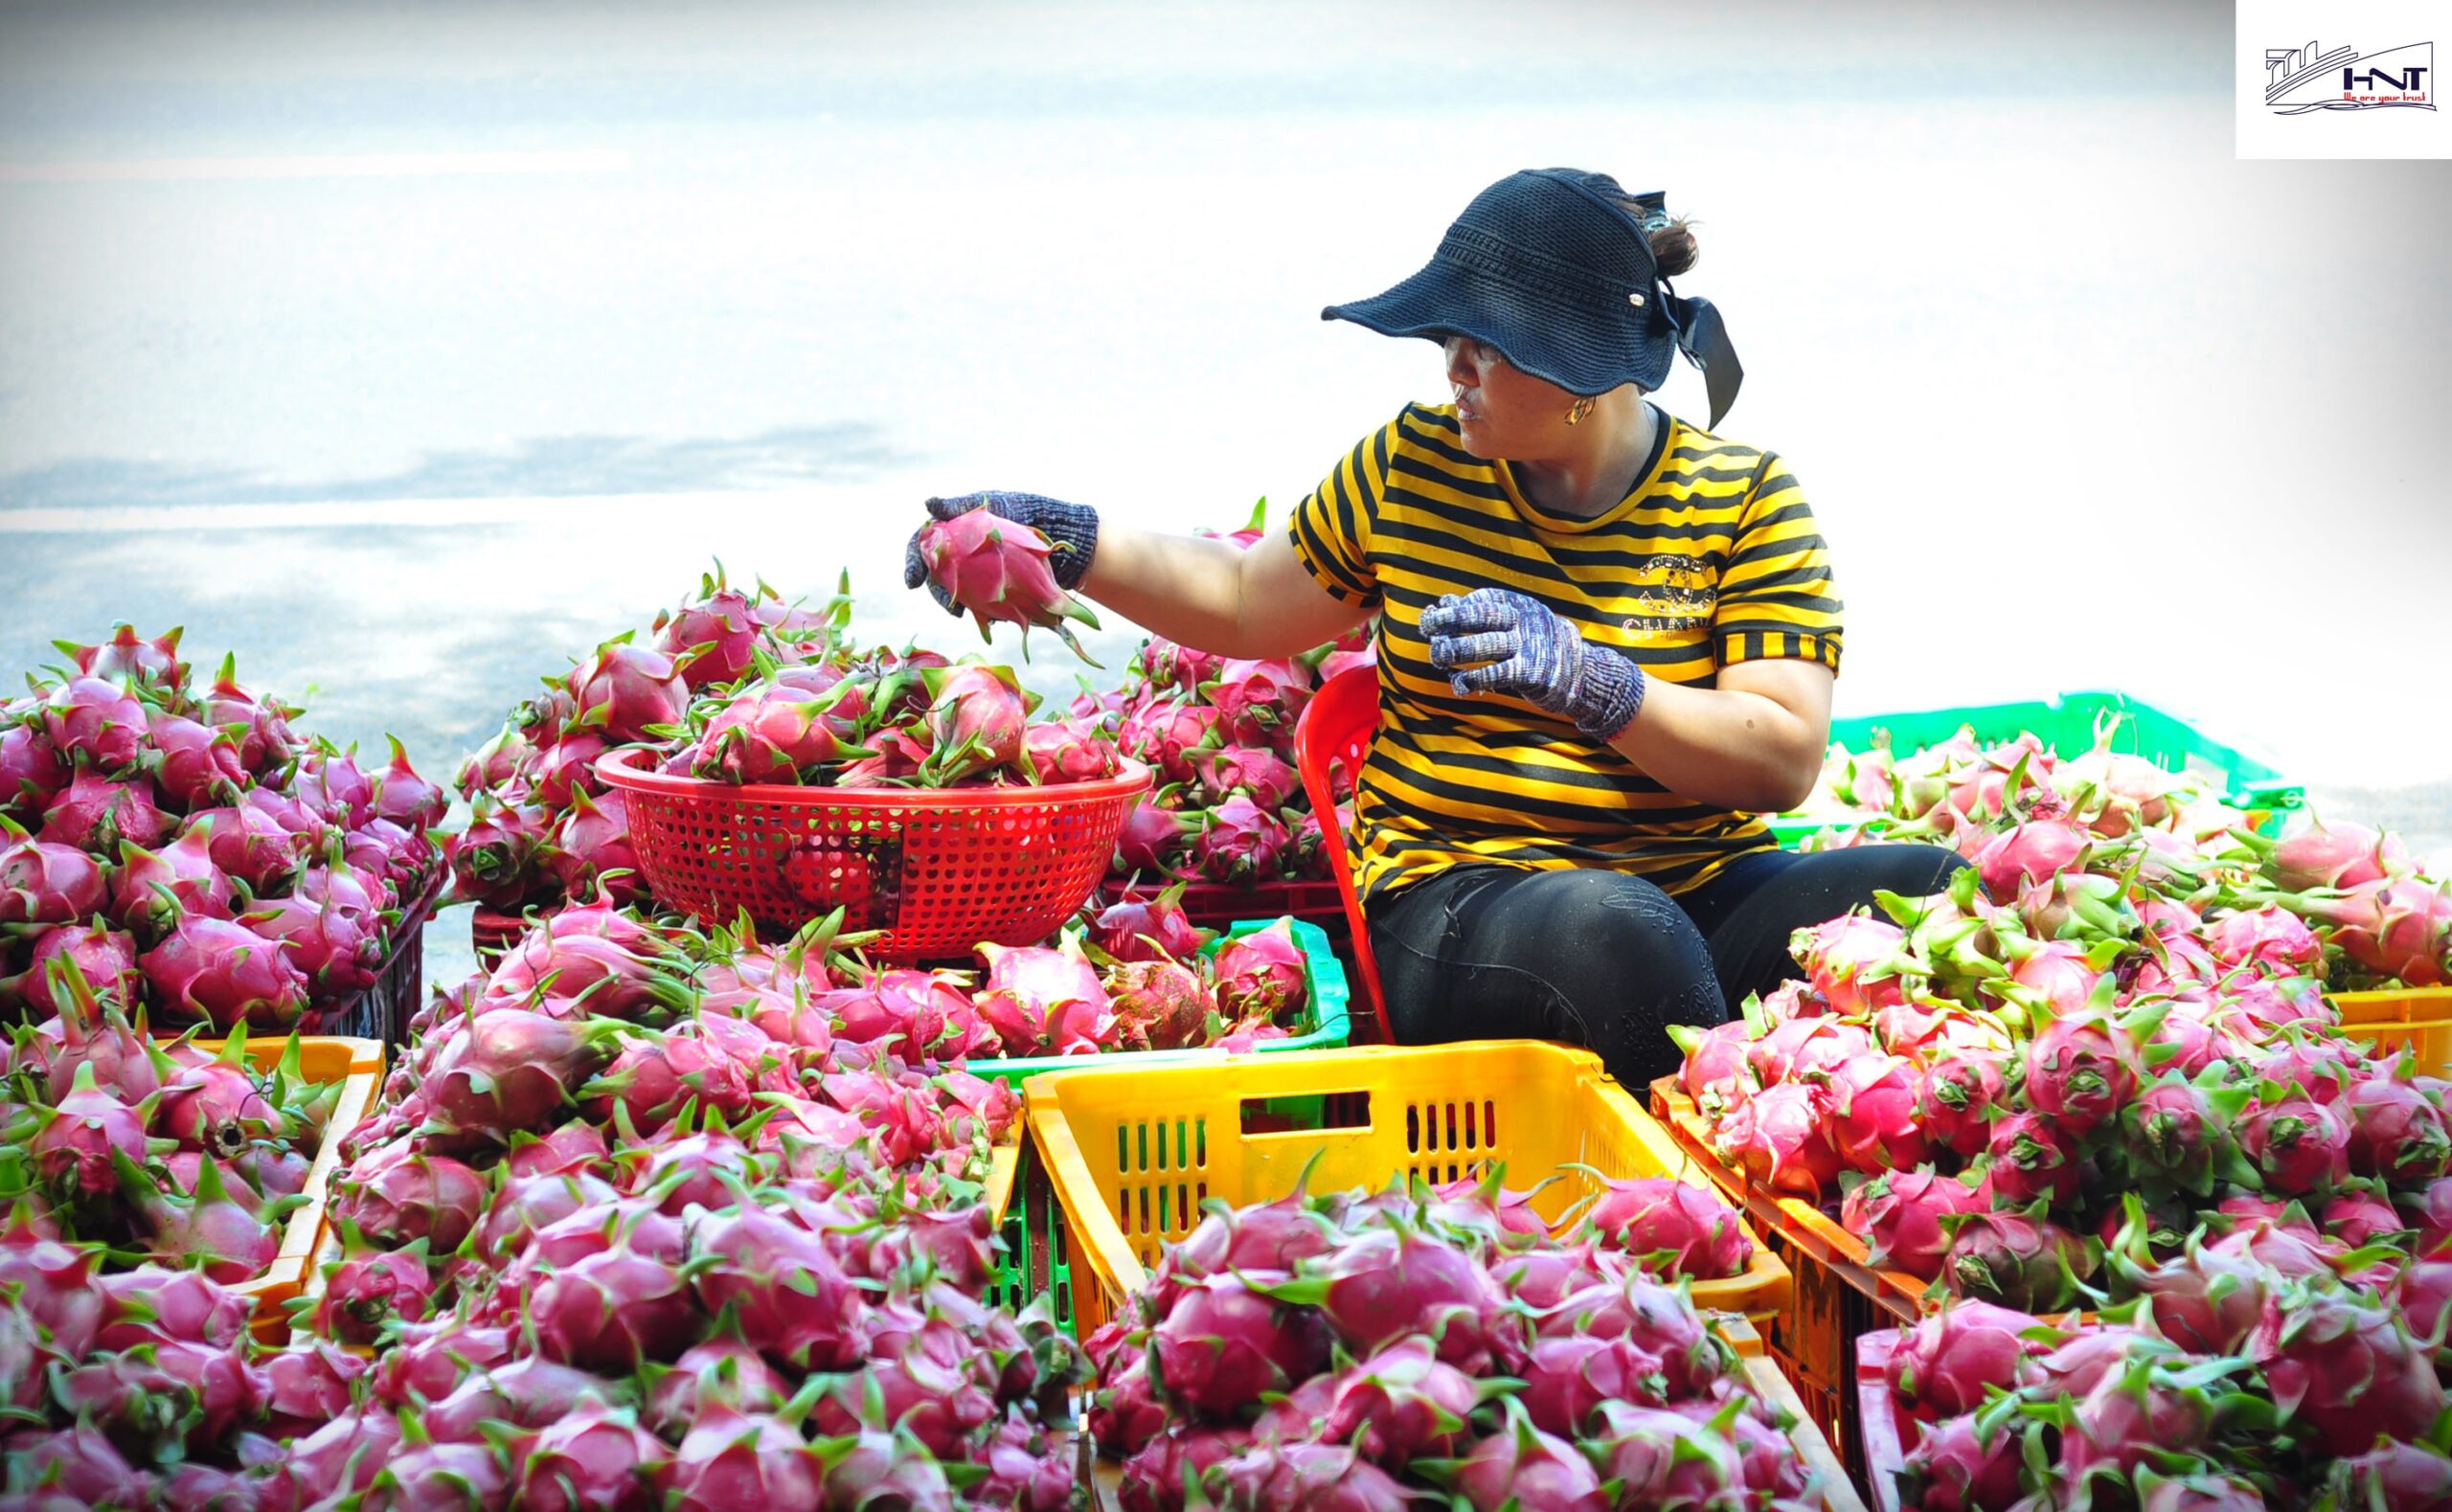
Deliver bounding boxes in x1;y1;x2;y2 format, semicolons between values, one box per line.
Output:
0;0;2452;965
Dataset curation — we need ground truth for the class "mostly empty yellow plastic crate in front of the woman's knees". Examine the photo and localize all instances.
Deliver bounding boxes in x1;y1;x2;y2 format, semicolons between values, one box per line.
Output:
1025;1039;1790;1338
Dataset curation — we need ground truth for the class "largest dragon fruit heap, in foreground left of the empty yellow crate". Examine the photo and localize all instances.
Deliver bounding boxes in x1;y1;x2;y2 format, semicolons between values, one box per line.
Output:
259;899;1086;1509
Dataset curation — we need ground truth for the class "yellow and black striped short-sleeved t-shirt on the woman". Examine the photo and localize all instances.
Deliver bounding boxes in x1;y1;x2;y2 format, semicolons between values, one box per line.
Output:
1292;404;1839;897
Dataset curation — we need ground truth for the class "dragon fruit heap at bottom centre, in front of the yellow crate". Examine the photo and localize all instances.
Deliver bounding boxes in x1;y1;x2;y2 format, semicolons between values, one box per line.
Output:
1084;1171;1820;1512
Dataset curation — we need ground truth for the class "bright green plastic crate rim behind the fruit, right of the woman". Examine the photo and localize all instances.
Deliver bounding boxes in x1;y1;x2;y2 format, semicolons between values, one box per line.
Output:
1770;691;2307;847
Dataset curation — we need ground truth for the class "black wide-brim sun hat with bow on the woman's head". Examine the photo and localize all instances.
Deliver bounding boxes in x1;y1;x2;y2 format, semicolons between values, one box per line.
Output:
1319;169;1743;426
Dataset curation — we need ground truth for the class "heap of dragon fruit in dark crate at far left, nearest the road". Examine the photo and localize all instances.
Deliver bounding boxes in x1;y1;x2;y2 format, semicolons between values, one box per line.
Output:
0;625;448;1031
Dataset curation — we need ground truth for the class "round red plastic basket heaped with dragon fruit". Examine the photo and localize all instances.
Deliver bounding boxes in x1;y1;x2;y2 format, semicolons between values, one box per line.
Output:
596;750;1150;960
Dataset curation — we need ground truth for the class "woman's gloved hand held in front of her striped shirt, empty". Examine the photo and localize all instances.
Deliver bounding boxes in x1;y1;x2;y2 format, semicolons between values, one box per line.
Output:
1422;588;1646;745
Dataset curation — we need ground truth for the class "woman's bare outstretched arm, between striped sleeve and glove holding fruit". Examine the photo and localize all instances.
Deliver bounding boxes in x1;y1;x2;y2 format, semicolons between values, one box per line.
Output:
1078;522;1375;657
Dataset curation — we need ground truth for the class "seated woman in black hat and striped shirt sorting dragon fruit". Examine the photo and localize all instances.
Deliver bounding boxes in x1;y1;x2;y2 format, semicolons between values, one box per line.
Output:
905;169;1957;1083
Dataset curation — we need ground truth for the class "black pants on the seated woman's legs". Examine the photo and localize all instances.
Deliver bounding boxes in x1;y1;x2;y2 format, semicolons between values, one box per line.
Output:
1368;846;1966;1088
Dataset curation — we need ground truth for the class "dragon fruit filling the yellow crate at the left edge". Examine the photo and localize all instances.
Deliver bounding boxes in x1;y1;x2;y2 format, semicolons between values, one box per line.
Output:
0;981;343;1284
